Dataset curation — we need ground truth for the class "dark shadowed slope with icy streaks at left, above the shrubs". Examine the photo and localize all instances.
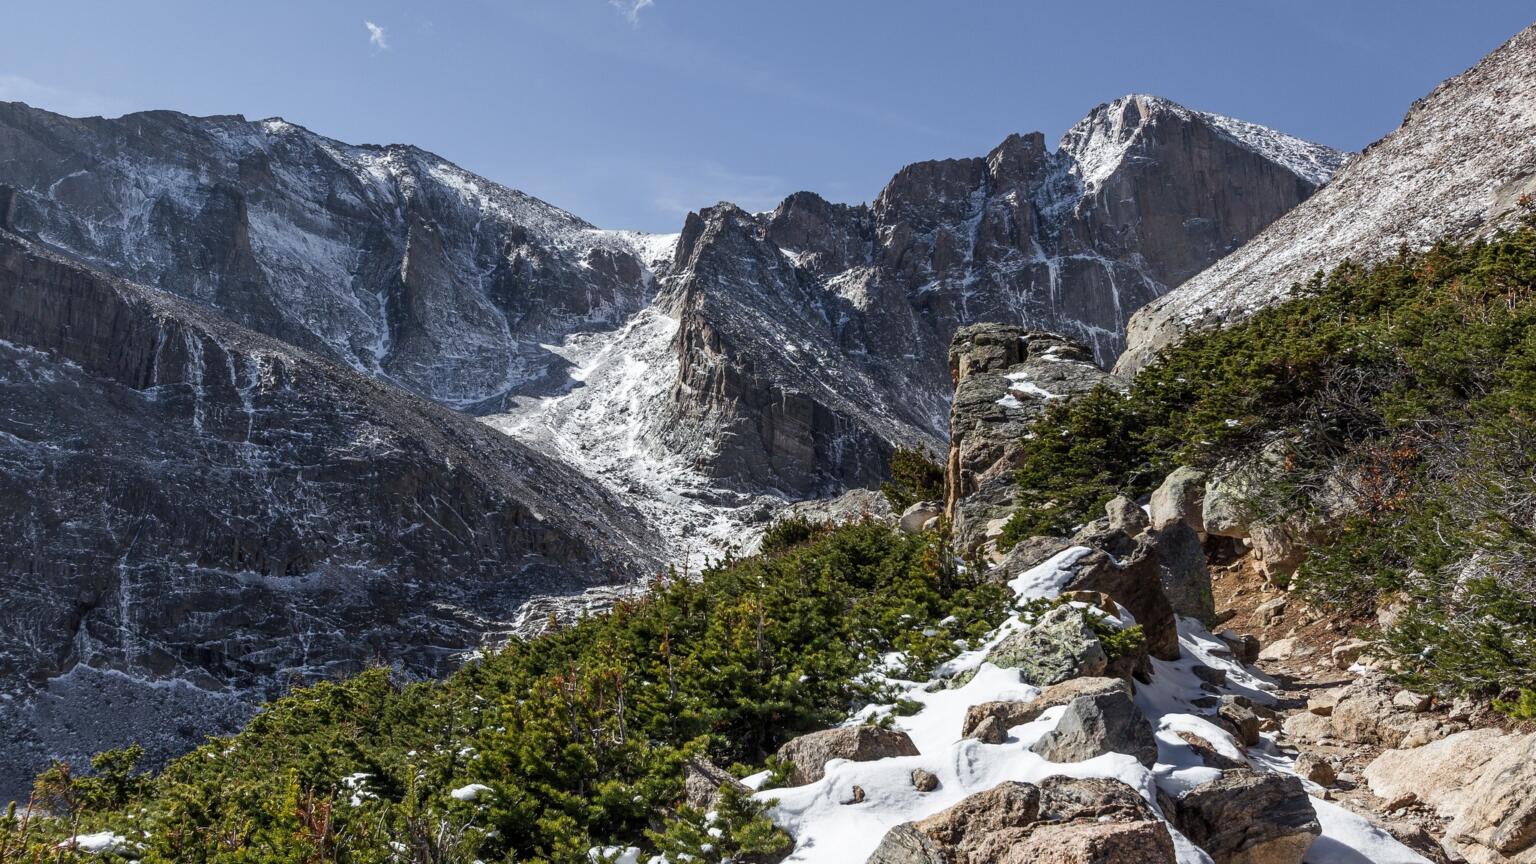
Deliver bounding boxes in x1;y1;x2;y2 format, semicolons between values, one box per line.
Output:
0;231;659;798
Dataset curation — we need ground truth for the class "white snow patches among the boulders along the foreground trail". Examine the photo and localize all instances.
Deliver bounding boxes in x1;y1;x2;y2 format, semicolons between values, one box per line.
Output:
757;547;1427;864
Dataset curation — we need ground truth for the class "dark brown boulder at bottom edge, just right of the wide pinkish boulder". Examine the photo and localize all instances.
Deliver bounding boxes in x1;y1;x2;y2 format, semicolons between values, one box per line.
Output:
1174;770;1322;864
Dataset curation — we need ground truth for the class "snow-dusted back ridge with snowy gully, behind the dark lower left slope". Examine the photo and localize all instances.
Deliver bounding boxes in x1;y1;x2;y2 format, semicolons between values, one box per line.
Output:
0;95;1342;561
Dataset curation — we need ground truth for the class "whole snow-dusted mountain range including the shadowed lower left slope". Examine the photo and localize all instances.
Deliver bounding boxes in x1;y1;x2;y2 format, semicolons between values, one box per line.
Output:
0;97;1342;784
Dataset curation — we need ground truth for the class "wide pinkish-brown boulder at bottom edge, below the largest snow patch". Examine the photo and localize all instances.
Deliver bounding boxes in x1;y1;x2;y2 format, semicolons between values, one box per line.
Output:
868;776;1175;864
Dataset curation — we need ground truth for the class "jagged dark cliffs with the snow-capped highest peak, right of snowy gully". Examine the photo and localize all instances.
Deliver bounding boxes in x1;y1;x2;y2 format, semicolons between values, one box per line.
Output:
635;95;1342;497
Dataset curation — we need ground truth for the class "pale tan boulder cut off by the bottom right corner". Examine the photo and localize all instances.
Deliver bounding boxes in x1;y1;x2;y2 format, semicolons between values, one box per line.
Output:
1445;733;1536;864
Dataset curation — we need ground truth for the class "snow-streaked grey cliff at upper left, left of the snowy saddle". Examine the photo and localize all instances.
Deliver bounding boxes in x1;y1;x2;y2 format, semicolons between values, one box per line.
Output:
0;103;651;414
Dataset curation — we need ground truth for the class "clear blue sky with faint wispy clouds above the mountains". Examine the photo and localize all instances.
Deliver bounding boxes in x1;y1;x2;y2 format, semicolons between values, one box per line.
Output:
0;0;1536;231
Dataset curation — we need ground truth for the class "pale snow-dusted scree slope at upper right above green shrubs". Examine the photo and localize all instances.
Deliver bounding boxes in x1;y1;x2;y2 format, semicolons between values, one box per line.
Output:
1115;25;1536;375
